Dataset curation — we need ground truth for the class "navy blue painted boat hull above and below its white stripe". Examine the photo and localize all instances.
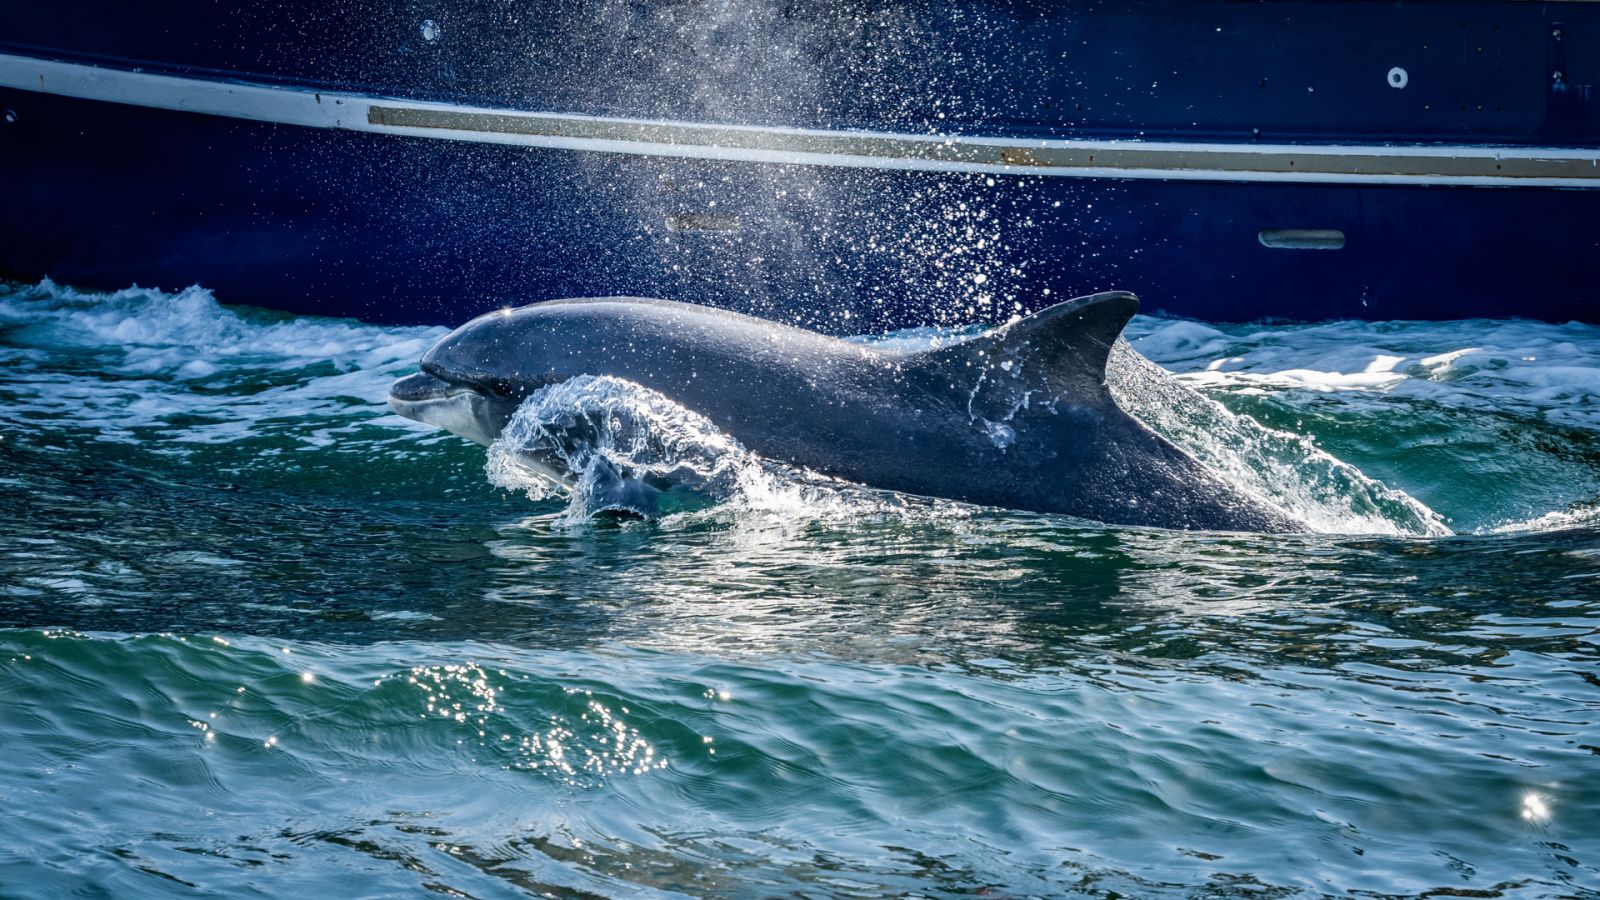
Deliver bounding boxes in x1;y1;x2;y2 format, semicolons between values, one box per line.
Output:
0;0;1600;321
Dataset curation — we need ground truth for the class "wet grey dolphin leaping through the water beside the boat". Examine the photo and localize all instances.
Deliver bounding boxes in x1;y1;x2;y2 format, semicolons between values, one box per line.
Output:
389;291;1306;532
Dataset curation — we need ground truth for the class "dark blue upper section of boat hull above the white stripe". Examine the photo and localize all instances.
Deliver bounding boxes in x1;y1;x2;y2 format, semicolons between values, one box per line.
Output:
0;0;1600;146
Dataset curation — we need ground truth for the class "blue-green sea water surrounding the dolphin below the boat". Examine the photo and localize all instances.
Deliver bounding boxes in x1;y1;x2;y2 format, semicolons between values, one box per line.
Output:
0;282;1600;897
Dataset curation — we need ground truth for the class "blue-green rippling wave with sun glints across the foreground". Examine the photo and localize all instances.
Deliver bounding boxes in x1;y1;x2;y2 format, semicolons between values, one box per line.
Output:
0;627;1597;897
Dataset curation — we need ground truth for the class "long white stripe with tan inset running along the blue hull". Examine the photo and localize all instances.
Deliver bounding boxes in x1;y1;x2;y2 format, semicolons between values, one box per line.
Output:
0;54;1600;187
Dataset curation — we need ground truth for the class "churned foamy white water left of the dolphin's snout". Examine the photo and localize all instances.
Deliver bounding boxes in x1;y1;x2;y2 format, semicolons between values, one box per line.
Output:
0;279;443;447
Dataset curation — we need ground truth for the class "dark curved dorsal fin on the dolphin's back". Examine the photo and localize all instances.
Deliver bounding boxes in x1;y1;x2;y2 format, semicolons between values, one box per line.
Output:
907;291;1139;394
